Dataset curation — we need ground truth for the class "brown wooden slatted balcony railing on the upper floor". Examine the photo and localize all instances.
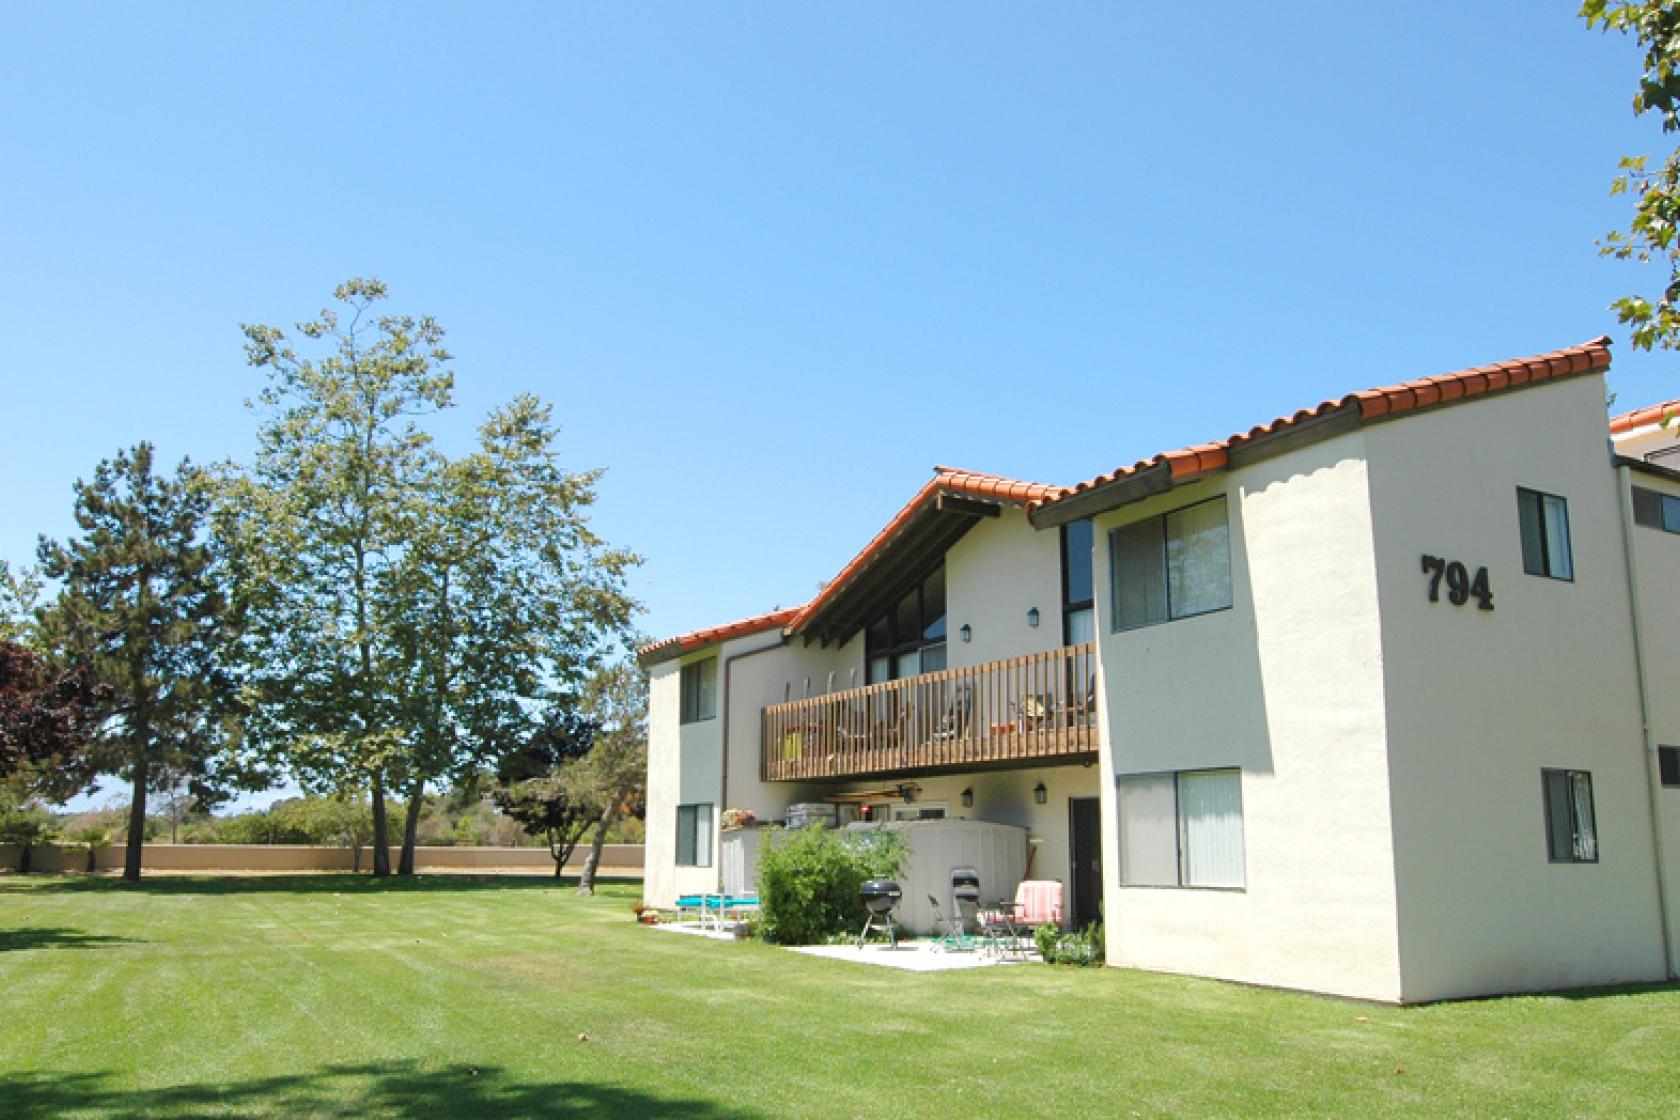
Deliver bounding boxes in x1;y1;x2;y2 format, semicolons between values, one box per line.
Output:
763;643;1097;781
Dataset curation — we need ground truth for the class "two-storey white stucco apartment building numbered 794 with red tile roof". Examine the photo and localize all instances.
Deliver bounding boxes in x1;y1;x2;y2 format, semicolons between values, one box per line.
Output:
642;339;1680;1002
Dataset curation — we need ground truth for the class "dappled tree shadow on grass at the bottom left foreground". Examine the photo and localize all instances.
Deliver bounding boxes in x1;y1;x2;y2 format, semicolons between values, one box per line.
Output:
0;1063;758;1120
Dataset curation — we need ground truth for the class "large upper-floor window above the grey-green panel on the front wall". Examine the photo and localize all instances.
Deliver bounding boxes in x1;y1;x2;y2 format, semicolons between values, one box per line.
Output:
1109;495;1231;630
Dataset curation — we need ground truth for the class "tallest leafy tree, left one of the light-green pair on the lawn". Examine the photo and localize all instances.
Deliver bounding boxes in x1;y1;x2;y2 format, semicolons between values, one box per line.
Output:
220;279;454;875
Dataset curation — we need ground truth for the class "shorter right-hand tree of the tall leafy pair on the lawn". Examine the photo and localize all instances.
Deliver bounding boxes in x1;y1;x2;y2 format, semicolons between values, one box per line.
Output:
393;396;637;873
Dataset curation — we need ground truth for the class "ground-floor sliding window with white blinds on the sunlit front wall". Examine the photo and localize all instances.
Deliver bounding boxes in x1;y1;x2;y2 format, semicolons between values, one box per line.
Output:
1119;771;1247;888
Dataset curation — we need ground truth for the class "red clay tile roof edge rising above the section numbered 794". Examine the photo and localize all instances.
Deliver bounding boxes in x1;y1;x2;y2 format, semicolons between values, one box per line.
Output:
1026;338;1612;512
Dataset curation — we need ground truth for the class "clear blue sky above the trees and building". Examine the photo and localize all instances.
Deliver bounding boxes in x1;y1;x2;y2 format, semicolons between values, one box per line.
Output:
0;0;1680;675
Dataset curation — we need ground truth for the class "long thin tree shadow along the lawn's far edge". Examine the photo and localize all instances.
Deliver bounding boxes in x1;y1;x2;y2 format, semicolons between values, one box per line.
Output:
8;871;642;897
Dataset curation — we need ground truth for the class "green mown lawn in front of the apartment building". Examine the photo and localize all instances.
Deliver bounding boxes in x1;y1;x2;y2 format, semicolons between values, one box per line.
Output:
0;875;1680;1120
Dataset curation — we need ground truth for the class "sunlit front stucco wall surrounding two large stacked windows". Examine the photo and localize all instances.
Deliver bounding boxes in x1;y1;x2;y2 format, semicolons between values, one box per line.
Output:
1095;435;1401;999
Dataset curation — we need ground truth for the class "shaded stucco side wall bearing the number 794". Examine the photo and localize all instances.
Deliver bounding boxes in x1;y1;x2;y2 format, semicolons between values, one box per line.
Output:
1366;376;1672;1001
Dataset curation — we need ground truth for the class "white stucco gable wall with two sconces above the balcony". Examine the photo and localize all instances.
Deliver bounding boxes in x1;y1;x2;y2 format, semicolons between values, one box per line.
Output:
946;507;1062;668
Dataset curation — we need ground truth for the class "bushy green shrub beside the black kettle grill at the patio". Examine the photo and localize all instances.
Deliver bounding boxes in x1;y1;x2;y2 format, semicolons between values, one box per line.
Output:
758;826;906;945
